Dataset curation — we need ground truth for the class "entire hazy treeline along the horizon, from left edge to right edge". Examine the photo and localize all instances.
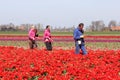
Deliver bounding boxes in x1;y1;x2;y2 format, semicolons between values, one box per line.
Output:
0;20;120;32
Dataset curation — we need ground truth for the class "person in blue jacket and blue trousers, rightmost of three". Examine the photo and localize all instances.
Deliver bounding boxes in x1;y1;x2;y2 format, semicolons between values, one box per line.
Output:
73;23;87;55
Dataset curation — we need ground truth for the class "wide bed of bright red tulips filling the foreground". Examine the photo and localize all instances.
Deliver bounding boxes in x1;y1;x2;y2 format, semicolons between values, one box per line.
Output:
0;47;120;80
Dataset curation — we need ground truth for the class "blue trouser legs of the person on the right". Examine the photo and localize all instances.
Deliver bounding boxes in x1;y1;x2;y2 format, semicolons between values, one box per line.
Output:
75;41;87;55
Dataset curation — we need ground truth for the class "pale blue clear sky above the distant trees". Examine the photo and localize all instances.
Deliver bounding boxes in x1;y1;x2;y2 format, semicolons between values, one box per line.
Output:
0;0;120;27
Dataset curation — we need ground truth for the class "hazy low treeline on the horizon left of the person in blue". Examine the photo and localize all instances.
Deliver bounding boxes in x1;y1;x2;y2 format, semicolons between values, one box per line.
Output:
0;23;75;32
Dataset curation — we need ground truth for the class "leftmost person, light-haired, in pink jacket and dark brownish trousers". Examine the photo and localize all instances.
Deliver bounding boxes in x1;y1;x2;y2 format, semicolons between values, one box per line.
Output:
28;26;38;49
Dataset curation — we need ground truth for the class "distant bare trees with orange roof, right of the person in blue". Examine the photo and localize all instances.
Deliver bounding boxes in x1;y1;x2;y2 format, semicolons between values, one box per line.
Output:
87;20;120;31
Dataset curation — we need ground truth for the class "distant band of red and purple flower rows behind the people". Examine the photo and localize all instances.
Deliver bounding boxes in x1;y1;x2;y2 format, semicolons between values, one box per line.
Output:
0;35;120;42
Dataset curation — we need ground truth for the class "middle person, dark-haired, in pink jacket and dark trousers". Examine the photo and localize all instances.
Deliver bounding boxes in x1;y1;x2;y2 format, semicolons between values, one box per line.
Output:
44;25;53;51
